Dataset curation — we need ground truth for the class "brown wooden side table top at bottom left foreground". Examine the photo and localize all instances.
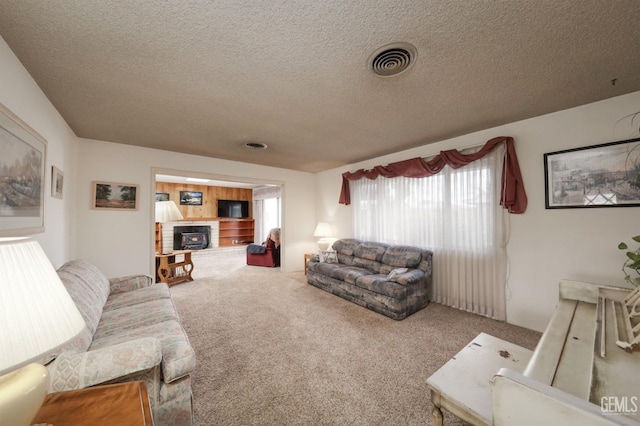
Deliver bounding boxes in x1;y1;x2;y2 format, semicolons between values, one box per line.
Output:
33;382;153;426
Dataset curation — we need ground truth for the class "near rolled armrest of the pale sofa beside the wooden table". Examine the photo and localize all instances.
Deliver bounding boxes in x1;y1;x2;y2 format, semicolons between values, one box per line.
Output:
47;337;162;392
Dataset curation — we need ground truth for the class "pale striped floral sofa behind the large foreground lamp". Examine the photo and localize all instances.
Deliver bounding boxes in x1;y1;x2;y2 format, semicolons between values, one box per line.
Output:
47;260;196;425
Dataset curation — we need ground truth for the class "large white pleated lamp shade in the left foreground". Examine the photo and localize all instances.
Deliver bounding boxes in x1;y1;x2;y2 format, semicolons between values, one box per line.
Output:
0;238;85;375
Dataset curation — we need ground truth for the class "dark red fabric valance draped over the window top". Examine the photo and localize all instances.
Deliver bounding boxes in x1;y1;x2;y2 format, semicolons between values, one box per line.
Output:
339;136;527;213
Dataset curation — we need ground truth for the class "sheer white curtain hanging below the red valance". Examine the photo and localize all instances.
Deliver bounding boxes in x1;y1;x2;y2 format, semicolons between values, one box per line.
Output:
350;149;507;320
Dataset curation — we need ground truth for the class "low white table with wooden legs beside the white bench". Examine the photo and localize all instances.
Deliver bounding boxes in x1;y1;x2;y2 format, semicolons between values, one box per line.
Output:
427;333;533;426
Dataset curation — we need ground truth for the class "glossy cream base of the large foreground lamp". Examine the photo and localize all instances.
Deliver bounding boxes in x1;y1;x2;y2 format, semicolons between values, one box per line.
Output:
0;363;49;426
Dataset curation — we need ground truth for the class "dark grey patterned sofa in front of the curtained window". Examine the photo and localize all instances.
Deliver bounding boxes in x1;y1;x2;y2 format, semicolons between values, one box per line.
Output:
307;239;433;320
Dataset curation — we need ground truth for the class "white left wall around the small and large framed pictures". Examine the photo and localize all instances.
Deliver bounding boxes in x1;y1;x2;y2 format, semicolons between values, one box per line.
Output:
0;38;77;268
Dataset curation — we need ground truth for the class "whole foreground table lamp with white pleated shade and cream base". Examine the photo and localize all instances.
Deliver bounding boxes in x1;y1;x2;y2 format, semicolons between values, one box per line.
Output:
0;237;85;426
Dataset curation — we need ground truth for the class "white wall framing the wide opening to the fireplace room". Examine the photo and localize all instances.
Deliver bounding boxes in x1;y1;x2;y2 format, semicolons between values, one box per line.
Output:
76;139;316;277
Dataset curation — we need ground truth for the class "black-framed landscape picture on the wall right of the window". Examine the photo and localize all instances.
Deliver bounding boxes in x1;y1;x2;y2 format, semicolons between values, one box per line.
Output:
544;138;640;209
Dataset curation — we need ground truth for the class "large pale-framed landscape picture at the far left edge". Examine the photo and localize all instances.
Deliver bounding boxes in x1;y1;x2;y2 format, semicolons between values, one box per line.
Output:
0;104;47;237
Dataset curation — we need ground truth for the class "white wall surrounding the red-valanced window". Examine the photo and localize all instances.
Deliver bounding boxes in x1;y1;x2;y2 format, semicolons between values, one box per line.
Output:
316;92;640;331
